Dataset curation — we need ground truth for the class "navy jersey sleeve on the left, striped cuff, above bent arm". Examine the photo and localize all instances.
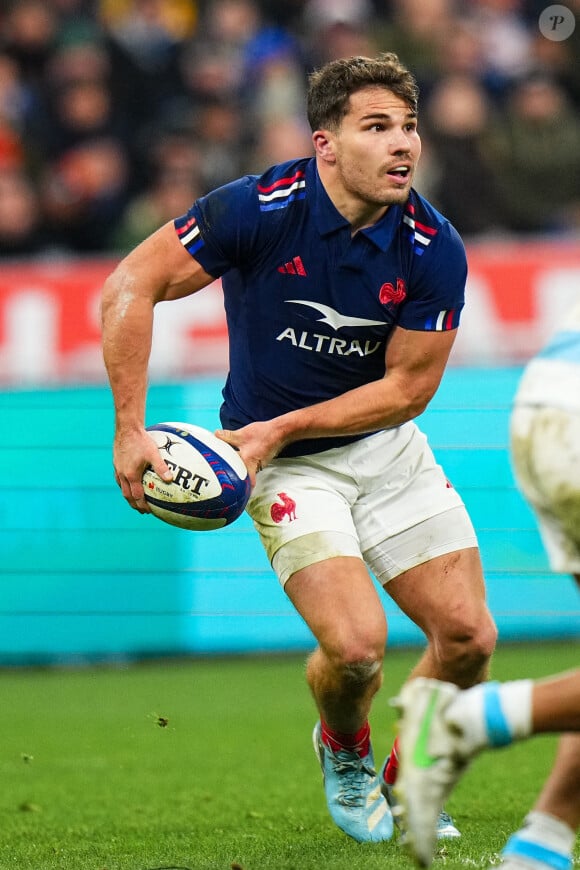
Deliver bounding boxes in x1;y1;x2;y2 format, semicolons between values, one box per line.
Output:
174;176;259;278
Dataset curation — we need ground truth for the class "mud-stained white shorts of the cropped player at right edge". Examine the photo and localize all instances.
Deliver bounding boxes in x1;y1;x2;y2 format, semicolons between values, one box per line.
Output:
510;405;580;574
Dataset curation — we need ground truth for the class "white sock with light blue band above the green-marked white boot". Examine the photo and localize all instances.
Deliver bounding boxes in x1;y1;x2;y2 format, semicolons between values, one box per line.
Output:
445;680;533;755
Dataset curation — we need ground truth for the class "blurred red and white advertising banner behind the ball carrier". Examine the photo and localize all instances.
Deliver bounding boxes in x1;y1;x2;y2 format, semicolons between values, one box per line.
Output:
0;242;580;386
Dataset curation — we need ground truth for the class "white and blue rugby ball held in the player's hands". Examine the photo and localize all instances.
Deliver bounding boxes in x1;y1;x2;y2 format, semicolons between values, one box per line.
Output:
143;423;251;531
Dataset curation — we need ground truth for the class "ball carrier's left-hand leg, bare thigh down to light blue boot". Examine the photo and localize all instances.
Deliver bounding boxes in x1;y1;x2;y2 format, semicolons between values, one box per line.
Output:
285;542;393;842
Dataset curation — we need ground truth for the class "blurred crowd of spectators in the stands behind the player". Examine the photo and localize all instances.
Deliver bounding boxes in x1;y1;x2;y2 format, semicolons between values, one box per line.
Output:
0;0;580;257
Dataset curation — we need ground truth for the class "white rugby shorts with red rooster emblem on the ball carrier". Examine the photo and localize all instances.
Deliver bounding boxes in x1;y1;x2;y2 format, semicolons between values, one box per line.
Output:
247;422;477;585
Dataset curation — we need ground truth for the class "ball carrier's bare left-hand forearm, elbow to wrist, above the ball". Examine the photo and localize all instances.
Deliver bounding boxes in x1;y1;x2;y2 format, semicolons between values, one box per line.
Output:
102;286;153;430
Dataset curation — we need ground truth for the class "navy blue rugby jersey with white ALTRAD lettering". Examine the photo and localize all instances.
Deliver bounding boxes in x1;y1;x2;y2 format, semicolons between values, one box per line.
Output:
175;158;467;455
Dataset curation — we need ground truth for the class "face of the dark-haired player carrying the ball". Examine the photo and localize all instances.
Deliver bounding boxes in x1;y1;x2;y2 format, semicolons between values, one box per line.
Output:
333;86;421;206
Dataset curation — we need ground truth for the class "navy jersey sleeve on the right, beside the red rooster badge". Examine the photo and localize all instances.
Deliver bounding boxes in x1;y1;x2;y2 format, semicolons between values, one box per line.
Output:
398;222;467;332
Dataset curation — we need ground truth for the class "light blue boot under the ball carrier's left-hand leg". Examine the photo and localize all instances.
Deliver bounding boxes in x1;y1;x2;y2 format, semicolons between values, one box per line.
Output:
312;722;393;843
